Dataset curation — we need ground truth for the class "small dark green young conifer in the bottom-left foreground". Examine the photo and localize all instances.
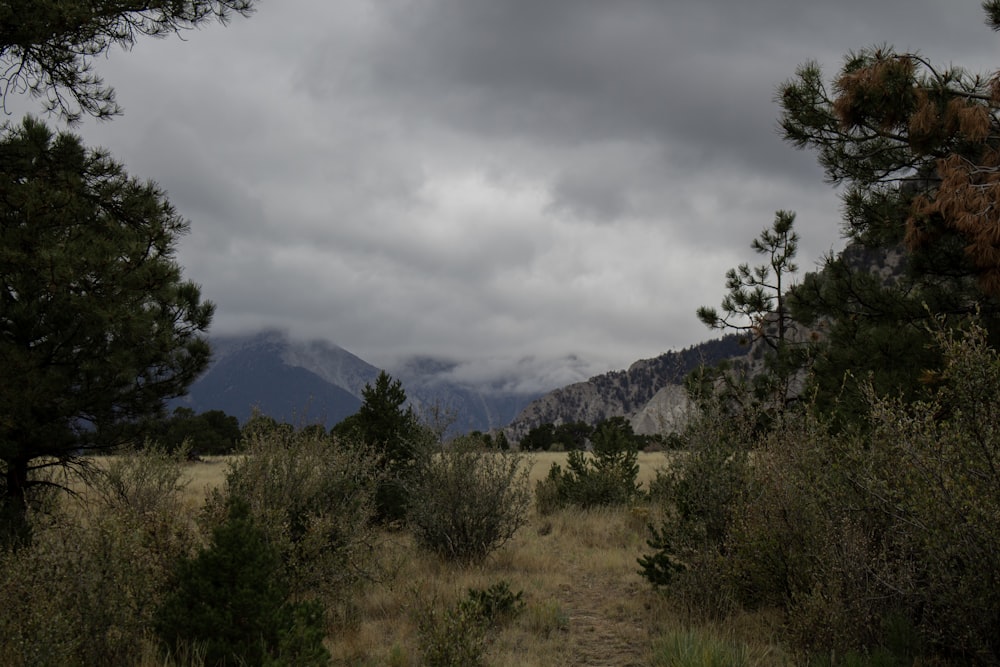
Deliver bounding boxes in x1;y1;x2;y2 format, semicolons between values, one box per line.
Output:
156;500;330;665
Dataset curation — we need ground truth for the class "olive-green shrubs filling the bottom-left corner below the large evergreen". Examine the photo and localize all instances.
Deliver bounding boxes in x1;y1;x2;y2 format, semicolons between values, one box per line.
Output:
0;448;194;665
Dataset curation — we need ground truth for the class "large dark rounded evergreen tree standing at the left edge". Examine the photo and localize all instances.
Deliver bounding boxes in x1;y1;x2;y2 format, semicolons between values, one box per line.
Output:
0;118;214;534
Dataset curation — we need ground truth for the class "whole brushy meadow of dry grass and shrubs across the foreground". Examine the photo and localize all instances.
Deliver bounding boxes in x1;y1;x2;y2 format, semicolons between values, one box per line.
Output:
7;340;1000;667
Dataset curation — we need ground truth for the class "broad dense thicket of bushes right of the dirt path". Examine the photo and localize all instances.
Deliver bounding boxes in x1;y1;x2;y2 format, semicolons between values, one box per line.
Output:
640;325;1000;664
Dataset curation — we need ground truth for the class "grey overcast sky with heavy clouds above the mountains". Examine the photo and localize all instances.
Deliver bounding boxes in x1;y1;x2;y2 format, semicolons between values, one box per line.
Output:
13;0;1000;388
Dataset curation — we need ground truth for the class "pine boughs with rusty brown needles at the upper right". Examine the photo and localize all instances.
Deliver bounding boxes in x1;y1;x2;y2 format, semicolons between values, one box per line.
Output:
779;9;1000;298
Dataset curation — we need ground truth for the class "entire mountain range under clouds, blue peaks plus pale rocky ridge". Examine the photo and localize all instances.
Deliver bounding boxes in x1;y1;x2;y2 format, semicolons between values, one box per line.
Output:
174;329;746;442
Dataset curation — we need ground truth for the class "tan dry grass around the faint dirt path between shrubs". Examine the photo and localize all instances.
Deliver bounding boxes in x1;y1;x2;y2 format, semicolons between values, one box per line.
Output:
160;452;785;667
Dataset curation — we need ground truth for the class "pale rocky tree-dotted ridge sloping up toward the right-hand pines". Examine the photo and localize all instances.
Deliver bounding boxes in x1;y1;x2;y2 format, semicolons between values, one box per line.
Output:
504;336;747;442
